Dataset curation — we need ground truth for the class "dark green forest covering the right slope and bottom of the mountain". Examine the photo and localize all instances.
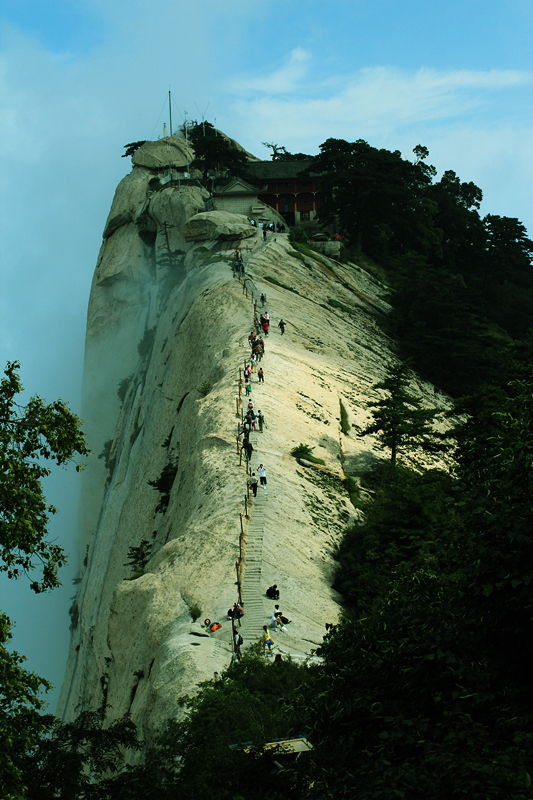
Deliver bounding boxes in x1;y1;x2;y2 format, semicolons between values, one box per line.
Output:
7;126;533;800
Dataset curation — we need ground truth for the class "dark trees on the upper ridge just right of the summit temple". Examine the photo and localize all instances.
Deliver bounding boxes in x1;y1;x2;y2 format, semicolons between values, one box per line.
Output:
307;139;533;396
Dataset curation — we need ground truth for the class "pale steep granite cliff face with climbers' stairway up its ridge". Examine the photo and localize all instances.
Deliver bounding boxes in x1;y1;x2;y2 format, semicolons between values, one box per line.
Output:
58;138;444;738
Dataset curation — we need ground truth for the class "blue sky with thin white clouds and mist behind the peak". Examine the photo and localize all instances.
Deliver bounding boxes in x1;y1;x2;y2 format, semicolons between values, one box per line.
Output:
0;0;533;706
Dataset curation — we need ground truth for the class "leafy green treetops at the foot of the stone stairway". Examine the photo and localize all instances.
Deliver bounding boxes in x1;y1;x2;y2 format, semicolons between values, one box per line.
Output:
120;645;309;800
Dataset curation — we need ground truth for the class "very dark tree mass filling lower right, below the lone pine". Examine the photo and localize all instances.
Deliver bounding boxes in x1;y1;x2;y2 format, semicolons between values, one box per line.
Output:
290;341;533;800
